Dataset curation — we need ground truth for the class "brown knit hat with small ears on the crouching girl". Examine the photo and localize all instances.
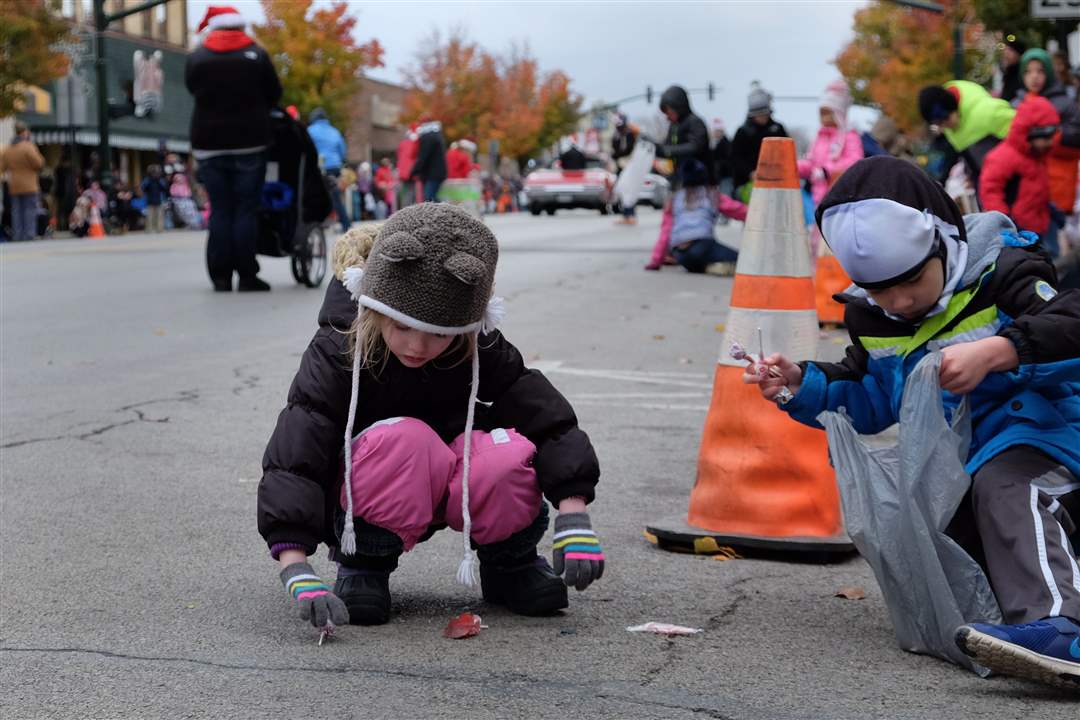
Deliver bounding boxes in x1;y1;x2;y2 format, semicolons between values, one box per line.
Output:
357;203;499;335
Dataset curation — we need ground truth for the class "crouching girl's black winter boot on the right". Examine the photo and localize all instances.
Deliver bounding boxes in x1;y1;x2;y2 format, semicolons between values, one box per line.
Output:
479;554;569;615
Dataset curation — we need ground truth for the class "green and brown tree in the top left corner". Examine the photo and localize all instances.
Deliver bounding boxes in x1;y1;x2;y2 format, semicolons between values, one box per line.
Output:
0;0;71;118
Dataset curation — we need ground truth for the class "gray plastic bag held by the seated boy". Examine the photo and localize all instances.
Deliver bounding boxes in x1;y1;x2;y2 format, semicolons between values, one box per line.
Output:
818;352;1001;676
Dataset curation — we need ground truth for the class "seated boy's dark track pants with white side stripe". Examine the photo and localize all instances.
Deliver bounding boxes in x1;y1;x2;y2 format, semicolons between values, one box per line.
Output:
947;446;1080;624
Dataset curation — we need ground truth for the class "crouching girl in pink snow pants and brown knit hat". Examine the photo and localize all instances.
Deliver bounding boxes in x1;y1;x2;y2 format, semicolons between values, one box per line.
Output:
258;203;604;625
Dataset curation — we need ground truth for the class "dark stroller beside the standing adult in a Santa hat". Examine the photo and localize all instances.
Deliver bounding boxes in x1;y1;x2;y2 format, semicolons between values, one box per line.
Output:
256;109;332;287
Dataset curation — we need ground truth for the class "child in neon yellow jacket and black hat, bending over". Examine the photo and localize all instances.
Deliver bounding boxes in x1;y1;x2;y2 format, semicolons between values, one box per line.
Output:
919;80;1016;188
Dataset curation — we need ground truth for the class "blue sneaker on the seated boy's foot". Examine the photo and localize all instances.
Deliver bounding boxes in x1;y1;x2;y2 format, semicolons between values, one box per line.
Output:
956;617;1080;692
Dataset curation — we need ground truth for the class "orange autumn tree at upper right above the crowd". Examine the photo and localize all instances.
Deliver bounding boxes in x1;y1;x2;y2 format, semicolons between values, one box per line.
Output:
835;0;993;133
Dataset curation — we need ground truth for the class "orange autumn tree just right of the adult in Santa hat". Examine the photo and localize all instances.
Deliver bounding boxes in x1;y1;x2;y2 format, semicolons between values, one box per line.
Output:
254;0;383;125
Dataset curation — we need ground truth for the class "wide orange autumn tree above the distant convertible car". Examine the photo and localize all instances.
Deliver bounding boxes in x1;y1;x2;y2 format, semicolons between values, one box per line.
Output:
402;31;581;162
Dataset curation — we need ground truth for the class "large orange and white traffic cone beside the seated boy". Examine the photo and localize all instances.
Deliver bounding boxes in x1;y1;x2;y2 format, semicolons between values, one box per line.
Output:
645;138;853;554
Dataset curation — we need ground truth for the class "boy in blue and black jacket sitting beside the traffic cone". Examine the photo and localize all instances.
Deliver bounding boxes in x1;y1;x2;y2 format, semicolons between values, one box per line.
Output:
743;157;1080;689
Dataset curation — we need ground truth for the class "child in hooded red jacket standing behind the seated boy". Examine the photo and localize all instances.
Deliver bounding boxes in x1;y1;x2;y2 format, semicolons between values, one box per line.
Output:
978;95;1061;235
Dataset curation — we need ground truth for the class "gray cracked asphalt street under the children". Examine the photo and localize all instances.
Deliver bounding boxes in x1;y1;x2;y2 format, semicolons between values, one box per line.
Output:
0;210;1078;720
